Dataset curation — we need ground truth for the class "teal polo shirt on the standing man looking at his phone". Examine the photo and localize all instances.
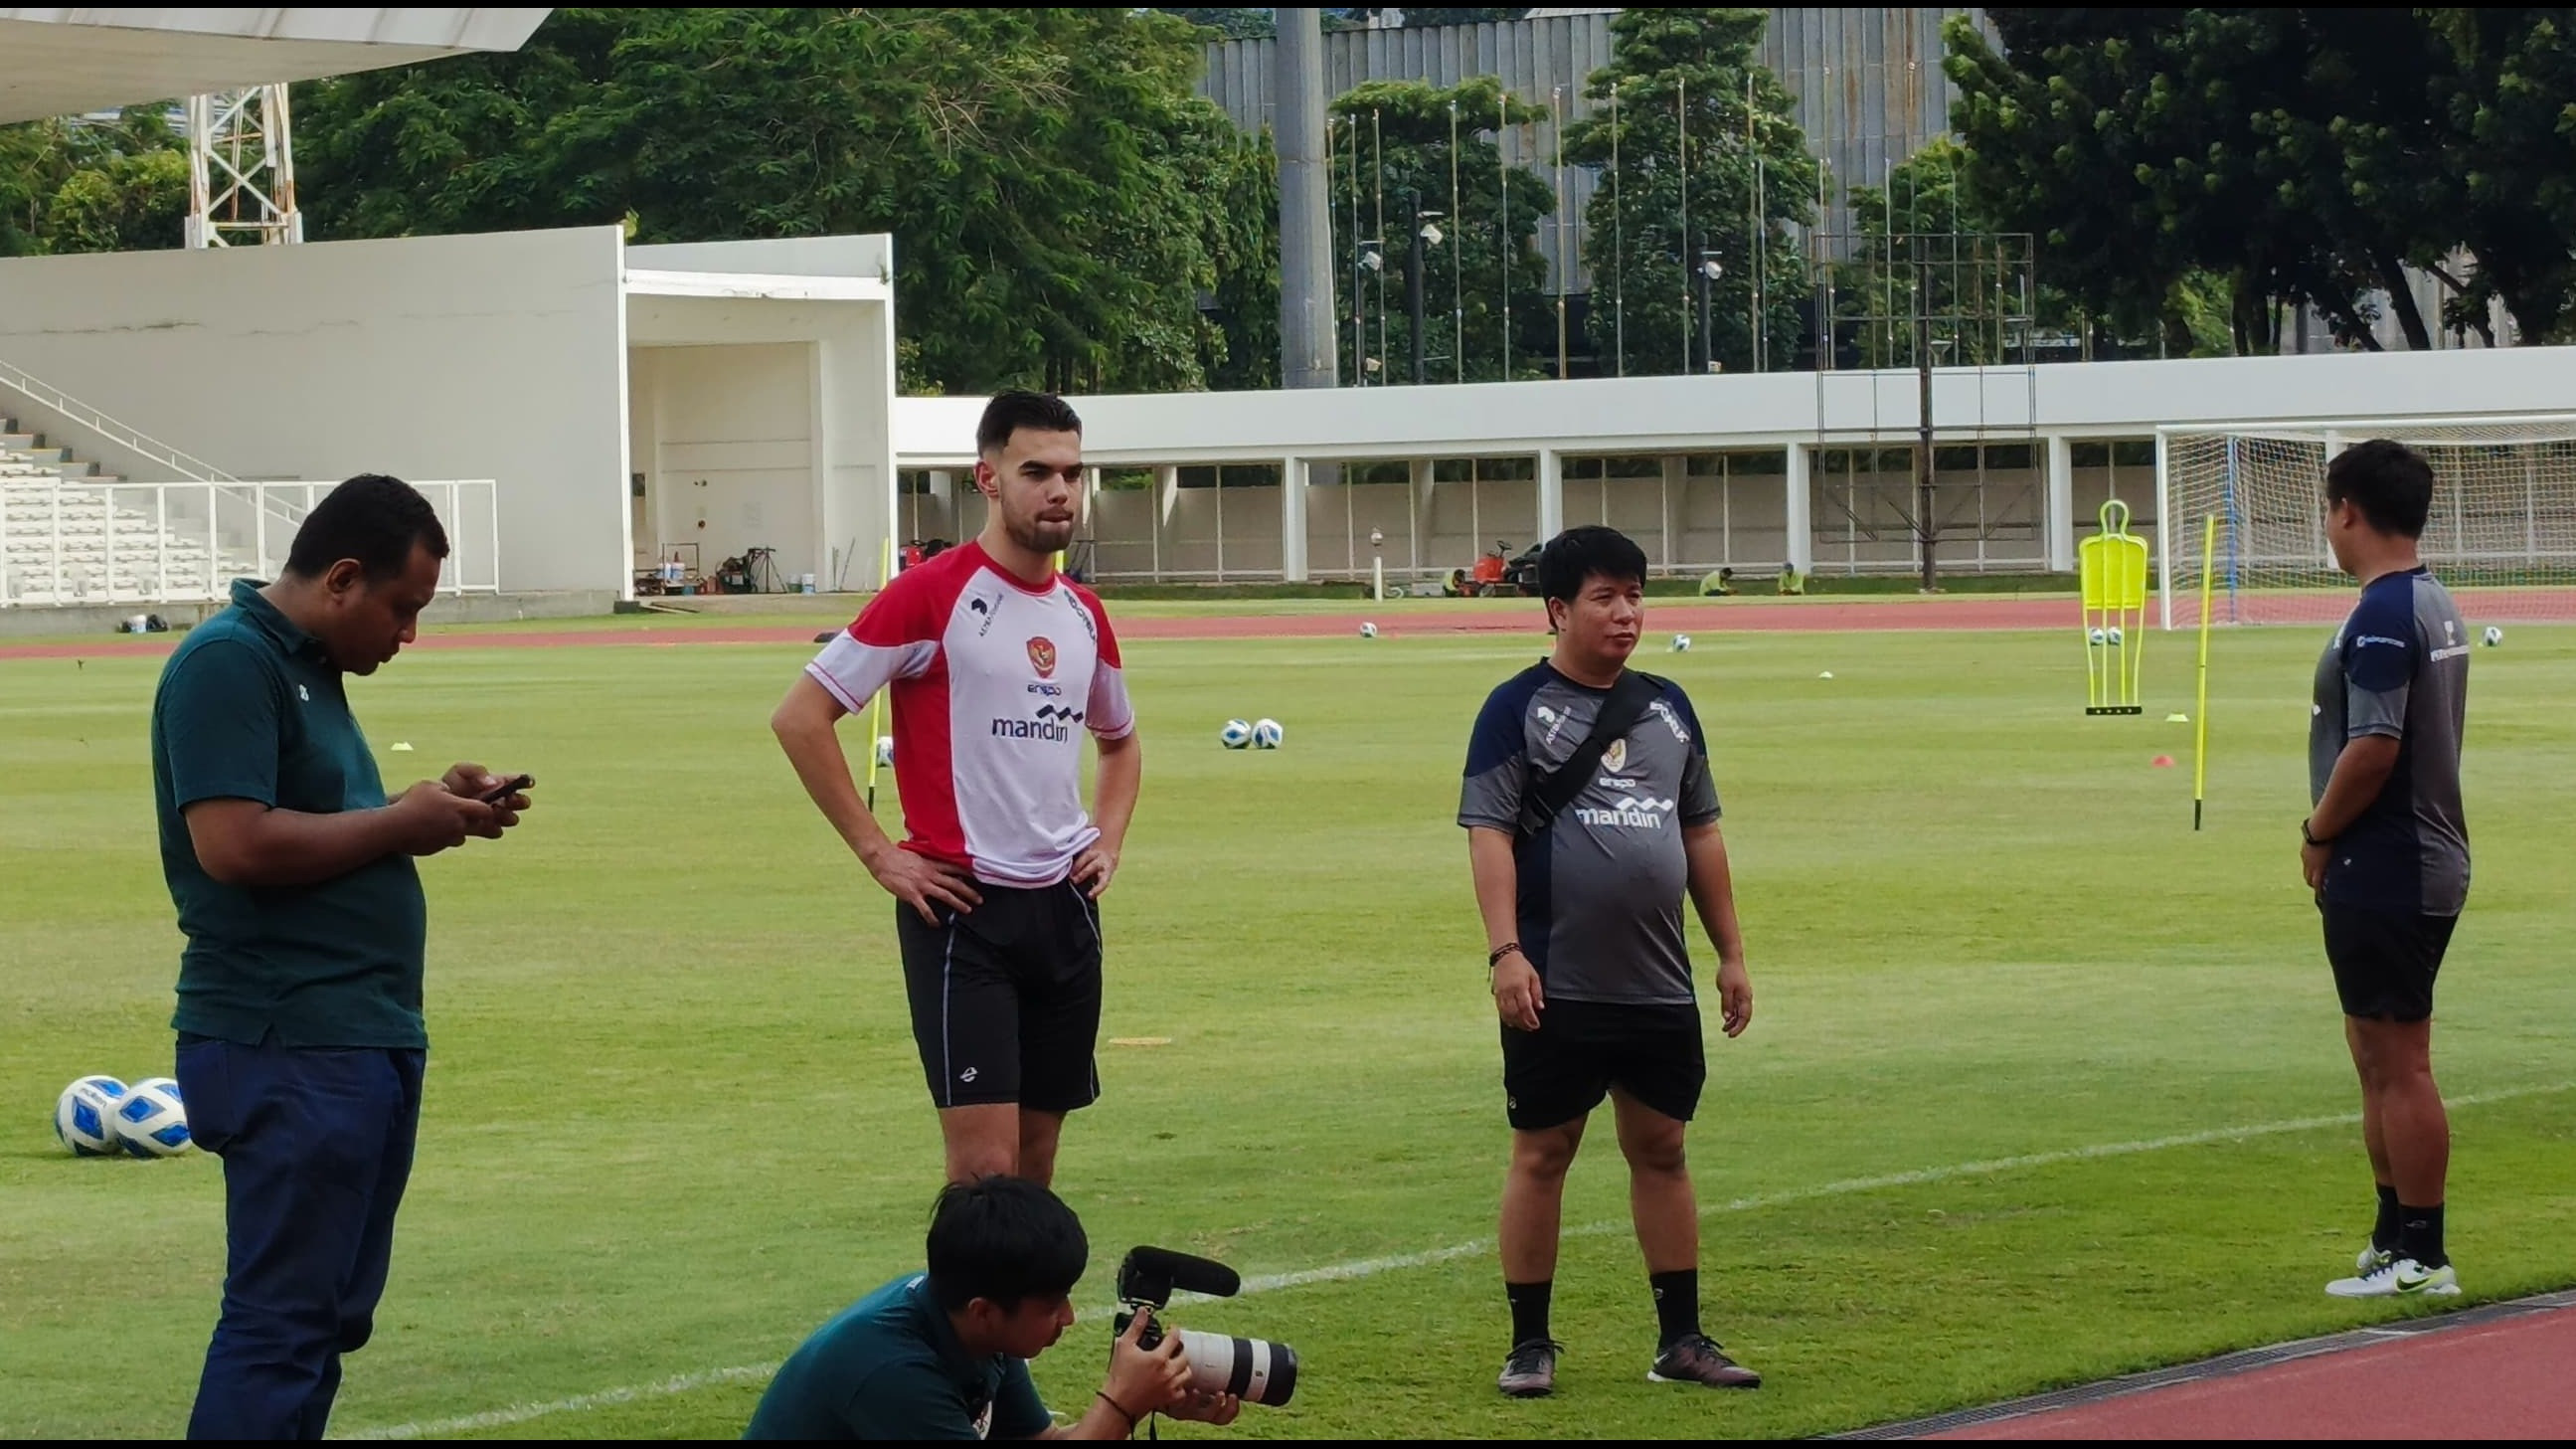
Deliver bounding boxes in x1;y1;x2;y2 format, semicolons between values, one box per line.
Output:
152;578;430;1047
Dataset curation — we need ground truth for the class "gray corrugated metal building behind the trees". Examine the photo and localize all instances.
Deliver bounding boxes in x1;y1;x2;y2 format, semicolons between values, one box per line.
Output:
1198;8;1991;291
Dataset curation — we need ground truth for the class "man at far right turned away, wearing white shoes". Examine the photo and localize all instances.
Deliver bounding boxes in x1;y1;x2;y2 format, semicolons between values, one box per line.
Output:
2298;439;2468;1297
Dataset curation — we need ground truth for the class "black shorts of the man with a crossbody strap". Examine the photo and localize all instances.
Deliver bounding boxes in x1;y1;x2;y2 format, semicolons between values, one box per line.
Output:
1502;1000;1708;1132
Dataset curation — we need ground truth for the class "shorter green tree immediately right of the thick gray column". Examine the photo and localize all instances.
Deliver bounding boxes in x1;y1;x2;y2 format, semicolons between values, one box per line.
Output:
1332;75;1556;384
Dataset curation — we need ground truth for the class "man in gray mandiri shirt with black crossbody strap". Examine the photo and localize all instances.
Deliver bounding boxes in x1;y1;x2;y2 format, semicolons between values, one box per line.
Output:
1459;528;1762;1397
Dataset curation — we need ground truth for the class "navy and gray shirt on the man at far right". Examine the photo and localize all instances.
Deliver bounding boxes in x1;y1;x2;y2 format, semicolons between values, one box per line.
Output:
2309;567;2468;915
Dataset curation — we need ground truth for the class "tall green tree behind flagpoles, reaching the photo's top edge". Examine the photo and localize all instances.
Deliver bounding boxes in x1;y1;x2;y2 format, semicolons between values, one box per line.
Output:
1566;8;1818;374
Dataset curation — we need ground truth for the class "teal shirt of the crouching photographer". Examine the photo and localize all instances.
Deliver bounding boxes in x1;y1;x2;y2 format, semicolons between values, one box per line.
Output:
742;1274;1054;1439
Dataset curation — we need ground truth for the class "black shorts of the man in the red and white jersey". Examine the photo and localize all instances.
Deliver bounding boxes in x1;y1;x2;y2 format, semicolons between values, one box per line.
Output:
894;882;1100;1111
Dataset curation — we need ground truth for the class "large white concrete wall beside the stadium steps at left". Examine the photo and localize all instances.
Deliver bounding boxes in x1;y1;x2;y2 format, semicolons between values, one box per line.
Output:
0;227;631;591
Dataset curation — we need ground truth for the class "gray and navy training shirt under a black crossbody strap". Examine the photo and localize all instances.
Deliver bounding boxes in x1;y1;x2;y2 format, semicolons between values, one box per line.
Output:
1459;662;1718;1005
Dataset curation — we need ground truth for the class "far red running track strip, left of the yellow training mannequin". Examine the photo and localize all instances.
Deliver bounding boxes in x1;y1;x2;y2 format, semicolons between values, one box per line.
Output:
0;598;2079;660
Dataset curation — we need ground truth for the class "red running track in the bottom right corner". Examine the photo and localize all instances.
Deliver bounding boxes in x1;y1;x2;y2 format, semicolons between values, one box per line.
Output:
1932;1307;2576;1439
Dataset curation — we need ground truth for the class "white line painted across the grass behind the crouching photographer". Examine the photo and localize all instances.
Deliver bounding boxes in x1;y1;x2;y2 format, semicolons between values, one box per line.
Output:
345;1080;2576;1439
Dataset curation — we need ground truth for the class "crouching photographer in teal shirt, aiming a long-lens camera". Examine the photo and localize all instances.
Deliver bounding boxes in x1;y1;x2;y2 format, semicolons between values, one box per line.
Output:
742;1176;1242;1439
